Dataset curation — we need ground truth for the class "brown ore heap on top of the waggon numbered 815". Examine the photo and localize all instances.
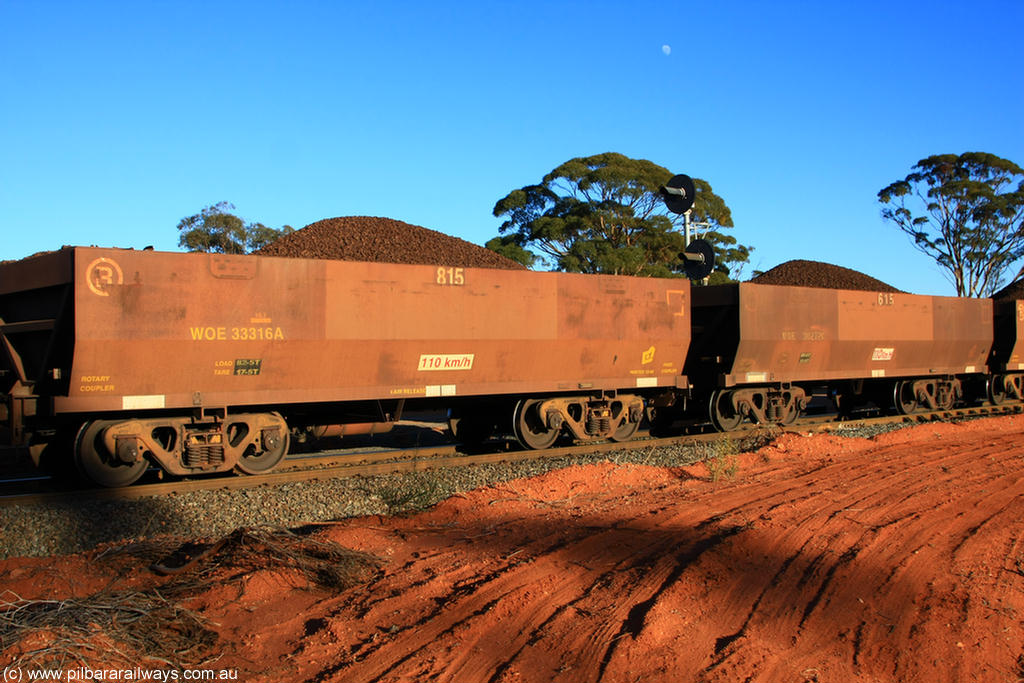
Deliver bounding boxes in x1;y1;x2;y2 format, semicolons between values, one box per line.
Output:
256;216;524;270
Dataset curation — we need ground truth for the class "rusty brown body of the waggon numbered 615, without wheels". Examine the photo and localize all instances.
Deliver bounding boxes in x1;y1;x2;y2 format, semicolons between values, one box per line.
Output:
687;283;992;386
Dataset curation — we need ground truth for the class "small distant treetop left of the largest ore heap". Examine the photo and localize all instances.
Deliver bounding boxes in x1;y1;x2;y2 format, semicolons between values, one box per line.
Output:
178;202;295;254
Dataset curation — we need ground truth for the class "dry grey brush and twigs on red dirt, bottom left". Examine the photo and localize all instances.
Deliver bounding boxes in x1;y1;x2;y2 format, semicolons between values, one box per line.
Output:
0;528;380;671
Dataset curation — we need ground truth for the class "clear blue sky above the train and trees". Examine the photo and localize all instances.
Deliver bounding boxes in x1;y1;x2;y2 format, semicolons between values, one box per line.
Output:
0;0;1024;295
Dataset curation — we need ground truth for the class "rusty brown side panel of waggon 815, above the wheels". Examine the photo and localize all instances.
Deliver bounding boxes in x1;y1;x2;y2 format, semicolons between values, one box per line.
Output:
6;248;689;413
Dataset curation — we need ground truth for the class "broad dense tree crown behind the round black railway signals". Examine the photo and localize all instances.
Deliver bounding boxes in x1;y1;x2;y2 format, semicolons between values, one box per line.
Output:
486;153;751;282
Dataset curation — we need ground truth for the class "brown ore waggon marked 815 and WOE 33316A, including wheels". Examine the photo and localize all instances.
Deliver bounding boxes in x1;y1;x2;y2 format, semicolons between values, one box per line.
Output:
0;247;690;485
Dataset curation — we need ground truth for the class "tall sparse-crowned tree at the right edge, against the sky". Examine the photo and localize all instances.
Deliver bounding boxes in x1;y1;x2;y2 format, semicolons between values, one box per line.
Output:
879;152;1024;296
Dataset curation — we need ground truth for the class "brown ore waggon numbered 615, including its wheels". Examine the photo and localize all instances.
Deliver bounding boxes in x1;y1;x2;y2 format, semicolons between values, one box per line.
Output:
684;283;993;430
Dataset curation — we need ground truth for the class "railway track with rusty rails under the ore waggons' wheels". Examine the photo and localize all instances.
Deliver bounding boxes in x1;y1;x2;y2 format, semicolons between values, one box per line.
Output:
0;403;1024;507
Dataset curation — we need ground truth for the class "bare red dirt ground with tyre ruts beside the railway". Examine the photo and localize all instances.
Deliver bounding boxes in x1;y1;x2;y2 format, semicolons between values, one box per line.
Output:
0;416;1024;683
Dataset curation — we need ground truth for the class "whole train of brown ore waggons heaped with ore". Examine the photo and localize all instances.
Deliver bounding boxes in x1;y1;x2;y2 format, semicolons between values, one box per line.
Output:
0;176;1024;486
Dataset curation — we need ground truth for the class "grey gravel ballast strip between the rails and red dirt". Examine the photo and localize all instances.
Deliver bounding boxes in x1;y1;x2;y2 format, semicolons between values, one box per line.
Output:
0;436;769;558
